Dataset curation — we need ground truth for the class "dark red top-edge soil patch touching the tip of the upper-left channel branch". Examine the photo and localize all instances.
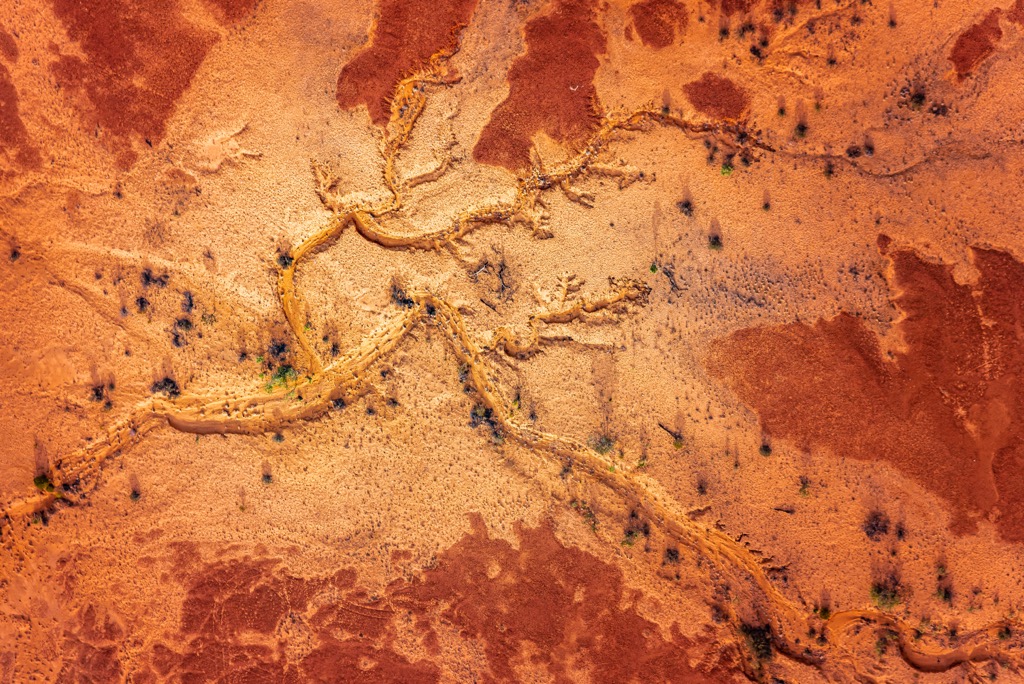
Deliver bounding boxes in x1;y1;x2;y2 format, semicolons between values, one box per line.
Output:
337;0;476;126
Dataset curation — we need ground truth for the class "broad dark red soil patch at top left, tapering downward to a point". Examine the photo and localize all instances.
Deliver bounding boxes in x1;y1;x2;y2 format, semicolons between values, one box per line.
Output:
51;0;215;168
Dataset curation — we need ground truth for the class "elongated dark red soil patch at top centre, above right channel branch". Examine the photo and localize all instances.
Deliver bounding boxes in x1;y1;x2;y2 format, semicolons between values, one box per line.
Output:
473;0;605;171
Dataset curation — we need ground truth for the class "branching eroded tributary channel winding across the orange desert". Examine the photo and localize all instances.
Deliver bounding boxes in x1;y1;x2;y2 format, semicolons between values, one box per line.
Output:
3;45;1021;680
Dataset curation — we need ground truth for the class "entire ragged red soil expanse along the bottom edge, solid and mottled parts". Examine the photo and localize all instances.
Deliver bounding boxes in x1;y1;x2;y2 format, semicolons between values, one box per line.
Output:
61;515;732;684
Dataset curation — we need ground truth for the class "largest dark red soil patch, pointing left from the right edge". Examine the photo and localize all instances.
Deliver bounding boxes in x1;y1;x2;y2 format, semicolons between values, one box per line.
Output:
709;239;1024;542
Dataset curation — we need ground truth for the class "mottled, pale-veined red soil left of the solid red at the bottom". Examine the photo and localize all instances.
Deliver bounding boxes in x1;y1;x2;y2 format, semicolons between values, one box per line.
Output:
142;548;438;682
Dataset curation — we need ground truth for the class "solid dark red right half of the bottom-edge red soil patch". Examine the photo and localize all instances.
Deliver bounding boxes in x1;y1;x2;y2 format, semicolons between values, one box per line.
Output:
399;516;725;684
